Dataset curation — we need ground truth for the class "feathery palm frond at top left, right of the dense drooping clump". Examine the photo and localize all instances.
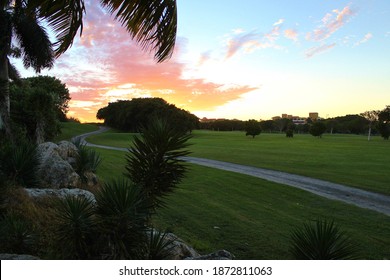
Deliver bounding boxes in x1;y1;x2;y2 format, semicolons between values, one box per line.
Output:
29;0;85;57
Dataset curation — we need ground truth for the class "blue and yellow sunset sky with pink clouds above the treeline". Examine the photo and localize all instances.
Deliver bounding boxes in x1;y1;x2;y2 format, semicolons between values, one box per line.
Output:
15;0;390;122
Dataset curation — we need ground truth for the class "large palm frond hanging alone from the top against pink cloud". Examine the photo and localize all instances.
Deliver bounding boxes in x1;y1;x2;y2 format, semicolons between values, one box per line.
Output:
101;0;177;62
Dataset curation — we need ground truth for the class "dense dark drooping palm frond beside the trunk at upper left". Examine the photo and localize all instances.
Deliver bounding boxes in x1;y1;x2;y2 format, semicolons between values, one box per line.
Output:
14;8;54;72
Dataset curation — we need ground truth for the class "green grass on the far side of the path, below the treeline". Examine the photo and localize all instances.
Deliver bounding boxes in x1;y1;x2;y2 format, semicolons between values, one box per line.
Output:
88;131;390;195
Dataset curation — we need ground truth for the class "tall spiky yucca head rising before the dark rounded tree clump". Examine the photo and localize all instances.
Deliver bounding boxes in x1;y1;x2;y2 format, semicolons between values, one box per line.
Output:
125;120;191;206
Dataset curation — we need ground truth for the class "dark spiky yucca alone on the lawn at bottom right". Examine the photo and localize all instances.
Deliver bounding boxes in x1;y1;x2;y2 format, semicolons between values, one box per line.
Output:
290;220;358;260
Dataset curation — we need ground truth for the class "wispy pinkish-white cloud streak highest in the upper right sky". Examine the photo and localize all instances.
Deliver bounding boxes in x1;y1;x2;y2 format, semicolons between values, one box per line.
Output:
306;5;355;42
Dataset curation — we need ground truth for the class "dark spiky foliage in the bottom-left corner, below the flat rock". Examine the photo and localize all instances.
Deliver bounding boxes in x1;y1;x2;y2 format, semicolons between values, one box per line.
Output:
0;213;36;254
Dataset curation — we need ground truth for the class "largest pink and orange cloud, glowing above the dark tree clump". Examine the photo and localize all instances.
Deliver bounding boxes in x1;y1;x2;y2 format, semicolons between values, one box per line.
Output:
50;1;256;121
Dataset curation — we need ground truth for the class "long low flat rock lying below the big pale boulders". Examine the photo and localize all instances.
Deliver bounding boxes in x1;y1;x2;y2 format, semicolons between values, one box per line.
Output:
25;188;96;203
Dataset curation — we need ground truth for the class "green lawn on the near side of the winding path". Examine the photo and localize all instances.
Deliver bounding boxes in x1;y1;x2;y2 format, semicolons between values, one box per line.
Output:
92;149;390;259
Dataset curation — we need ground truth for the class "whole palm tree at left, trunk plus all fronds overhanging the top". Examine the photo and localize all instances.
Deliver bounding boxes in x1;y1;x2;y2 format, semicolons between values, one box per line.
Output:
0;0;177;140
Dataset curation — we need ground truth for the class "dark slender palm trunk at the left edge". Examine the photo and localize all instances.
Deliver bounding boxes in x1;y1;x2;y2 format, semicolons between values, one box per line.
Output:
0;55;13;140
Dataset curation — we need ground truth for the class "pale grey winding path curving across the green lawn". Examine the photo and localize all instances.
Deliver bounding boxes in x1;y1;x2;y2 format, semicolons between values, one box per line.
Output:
75;127;390;216
